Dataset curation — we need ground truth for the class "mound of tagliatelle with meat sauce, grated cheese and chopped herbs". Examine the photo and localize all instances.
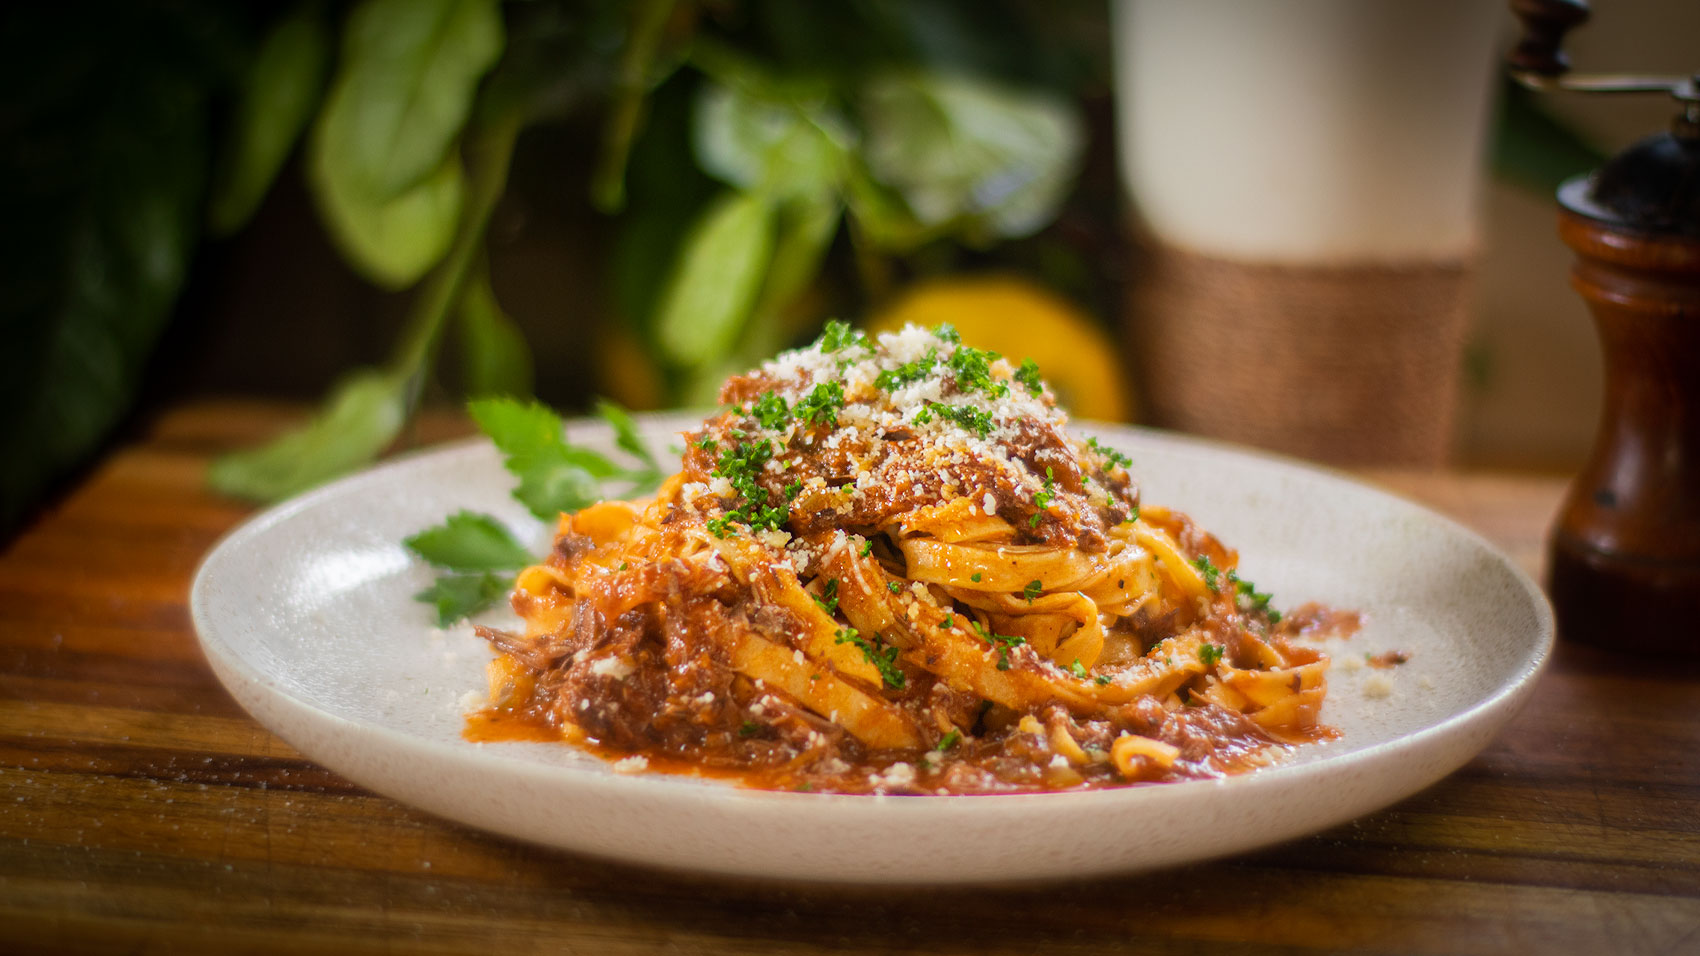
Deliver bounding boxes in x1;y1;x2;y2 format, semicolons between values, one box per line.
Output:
471;323;1328;793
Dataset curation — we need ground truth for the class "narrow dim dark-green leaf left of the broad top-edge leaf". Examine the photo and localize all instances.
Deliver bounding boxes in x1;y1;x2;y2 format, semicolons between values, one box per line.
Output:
207;3;330;235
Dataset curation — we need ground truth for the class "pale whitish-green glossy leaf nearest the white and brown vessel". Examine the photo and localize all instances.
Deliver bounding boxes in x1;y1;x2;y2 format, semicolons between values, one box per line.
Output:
859;70;1085;243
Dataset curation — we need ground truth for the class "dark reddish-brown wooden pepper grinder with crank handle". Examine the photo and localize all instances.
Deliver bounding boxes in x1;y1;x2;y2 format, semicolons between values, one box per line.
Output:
1510;0;1700;657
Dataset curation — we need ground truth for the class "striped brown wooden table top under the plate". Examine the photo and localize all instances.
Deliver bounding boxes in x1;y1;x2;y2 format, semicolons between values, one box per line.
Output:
0;403;1700;956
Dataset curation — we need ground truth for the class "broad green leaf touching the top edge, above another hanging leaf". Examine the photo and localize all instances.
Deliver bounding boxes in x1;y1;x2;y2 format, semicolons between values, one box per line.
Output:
318;0;503;204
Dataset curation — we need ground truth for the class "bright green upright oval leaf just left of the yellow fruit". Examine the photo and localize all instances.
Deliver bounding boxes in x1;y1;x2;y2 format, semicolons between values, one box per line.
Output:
655;192;774;367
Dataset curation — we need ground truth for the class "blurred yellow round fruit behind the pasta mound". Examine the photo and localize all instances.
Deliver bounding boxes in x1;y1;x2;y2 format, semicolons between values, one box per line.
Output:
869;276;1134;422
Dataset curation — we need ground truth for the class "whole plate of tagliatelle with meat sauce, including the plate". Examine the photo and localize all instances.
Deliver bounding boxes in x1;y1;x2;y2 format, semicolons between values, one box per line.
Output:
190;323;1552;883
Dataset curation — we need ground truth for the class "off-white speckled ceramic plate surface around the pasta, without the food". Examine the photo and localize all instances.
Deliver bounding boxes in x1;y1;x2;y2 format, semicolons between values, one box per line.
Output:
190;417;1552;883
